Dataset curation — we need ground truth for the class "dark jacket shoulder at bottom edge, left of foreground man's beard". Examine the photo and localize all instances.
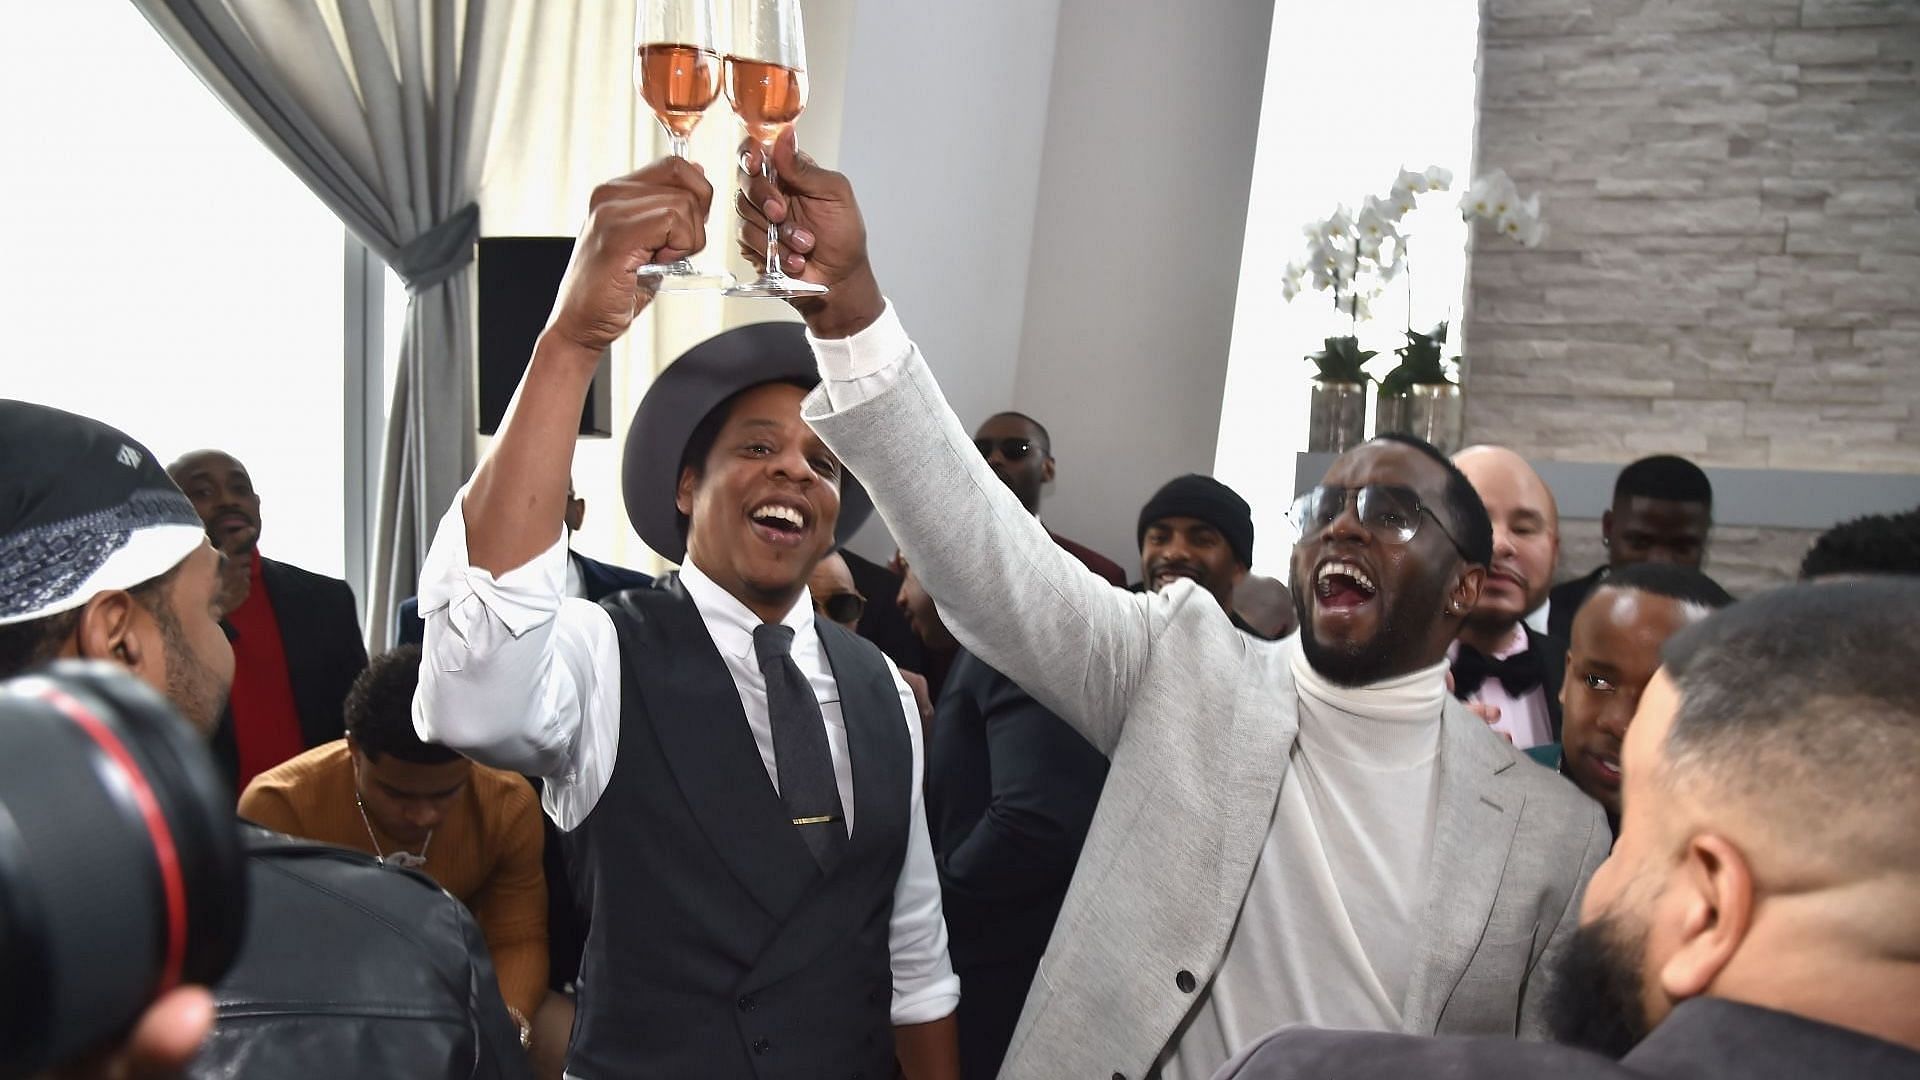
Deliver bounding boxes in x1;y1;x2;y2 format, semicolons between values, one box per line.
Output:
1221;1028;1632;1080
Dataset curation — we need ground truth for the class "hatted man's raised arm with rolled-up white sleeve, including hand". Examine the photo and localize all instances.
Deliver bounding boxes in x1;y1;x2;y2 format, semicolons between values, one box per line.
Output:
415;158;712;780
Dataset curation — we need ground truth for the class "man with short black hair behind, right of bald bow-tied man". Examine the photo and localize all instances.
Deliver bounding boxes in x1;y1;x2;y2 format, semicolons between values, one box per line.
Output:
1546;454;1713;642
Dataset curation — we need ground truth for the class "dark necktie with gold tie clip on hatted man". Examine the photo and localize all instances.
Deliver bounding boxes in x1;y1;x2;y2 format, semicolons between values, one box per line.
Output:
753;623;847;871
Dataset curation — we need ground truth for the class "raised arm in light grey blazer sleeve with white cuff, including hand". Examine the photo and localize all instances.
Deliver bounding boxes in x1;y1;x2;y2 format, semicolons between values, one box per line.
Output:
741;136;1190;753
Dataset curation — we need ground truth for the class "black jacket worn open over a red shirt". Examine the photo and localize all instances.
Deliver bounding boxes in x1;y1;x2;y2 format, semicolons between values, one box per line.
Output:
213;555;367;794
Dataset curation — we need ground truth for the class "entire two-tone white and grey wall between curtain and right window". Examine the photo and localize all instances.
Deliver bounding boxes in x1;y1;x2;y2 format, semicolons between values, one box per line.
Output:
803;0;1273;567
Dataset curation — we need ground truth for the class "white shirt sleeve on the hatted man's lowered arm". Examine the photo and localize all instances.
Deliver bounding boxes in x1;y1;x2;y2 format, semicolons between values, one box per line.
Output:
887;659;960;1024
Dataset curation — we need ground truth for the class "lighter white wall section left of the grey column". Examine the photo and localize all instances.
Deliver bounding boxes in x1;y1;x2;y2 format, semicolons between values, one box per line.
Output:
825;0;1060;557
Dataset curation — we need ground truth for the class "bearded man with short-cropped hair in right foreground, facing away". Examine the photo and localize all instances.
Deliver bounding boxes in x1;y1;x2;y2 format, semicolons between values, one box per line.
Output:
1221;578;1920;1080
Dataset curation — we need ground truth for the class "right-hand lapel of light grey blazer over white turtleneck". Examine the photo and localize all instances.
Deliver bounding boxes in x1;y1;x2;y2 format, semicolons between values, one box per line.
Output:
1404;698;1524;1034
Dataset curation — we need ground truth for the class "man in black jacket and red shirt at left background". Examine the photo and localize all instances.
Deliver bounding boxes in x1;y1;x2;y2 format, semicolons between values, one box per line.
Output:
167;450;367;792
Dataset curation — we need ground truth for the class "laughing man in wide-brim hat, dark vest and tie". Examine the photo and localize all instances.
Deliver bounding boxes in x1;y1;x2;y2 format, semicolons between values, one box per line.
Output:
415;158;960;1080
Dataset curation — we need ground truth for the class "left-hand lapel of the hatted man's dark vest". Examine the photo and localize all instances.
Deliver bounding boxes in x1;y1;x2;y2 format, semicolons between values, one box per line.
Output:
607;578;820;920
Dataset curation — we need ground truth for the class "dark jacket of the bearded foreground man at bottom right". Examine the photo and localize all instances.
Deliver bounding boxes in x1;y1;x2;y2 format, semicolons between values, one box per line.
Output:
1219;997;1920;1080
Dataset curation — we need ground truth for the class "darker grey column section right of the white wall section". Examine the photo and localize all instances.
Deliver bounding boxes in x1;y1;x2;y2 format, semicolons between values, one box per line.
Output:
1021;0;1273;573
